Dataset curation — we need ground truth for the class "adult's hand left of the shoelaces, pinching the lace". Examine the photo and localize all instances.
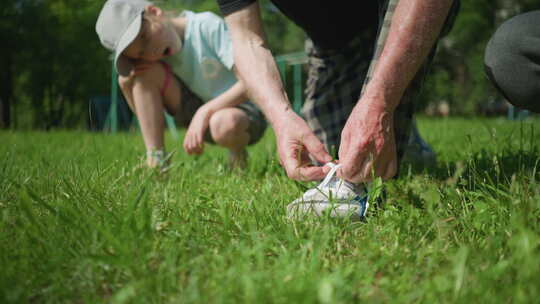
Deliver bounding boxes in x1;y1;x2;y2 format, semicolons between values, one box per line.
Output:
274;111;332;181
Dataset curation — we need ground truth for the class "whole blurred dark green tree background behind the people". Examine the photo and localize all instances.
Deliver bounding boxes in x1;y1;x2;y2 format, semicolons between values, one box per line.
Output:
0;0;540;130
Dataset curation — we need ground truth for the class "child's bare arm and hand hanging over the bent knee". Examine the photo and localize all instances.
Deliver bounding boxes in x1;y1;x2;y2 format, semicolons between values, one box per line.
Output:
184;81;247;154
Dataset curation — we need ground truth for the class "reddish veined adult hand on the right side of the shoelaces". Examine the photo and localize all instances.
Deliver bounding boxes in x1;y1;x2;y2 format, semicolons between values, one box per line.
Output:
338;103;397;183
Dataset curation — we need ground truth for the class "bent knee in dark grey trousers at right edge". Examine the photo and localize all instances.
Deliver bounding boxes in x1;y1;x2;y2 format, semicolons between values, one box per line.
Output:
484;11;540;112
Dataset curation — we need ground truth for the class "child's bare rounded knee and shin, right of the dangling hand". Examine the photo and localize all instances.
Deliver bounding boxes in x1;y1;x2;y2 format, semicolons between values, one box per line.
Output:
210;108;249;167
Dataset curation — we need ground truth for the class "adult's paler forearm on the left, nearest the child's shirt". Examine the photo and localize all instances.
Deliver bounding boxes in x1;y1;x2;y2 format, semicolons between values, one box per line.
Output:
225;3;291;125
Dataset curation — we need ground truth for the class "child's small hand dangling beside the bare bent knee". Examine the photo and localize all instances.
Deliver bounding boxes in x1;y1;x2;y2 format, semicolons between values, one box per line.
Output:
184;106;211;155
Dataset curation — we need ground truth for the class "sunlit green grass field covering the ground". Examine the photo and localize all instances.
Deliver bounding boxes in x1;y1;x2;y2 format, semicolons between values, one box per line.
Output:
0;118;540;303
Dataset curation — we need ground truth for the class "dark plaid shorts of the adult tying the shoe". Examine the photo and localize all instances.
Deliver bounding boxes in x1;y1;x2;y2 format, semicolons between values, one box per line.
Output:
301;0;459;164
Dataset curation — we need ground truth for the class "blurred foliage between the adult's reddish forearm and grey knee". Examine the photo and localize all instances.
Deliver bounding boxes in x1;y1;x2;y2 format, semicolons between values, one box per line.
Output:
420;0;540;114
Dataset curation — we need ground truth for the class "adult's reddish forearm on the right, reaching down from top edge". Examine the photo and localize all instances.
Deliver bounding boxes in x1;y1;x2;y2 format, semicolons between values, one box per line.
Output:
363;0;453;111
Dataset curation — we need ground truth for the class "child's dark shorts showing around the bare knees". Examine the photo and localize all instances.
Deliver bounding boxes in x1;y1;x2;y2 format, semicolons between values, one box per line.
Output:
174;77;267;145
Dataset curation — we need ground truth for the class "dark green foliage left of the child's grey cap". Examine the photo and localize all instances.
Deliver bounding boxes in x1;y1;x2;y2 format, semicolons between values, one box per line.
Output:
1;0;109;128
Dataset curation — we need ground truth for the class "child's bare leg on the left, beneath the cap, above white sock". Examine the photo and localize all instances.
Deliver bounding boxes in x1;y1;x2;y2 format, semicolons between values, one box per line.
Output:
119;63;180;167
